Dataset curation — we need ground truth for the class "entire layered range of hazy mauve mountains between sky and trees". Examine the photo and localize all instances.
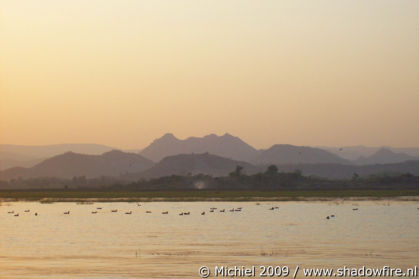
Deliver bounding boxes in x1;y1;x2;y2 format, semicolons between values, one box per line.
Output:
0;134;419;182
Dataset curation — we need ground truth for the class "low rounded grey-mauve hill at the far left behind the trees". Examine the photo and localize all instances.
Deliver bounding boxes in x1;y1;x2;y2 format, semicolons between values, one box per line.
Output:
0;150;154;180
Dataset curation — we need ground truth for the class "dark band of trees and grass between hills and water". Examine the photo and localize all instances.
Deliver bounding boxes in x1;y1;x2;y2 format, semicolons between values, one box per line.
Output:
0;165;419;202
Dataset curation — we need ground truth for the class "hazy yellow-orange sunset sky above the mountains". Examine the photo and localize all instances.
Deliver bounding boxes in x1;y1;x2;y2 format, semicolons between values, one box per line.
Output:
0;0;419;151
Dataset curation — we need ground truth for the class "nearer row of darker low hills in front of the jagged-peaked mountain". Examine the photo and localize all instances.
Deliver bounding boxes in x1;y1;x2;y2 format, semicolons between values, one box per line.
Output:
0;151;419;181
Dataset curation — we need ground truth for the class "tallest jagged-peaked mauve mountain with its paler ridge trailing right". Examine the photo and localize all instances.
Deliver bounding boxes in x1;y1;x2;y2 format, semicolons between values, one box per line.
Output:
140;133;419;165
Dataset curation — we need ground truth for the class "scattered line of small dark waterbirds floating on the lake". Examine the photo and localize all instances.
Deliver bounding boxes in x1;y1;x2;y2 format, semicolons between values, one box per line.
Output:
2;203;380;220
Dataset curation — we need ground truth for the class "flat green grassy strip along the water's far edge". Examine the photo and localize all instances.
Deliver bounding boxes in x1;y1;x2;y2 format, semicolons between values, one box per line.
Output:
0;190;419;202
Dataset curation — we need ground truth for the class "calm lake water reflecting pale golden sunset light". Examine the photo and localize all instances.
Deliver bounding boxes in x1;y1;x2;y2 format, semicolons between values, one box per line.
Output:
0;201;419;279
